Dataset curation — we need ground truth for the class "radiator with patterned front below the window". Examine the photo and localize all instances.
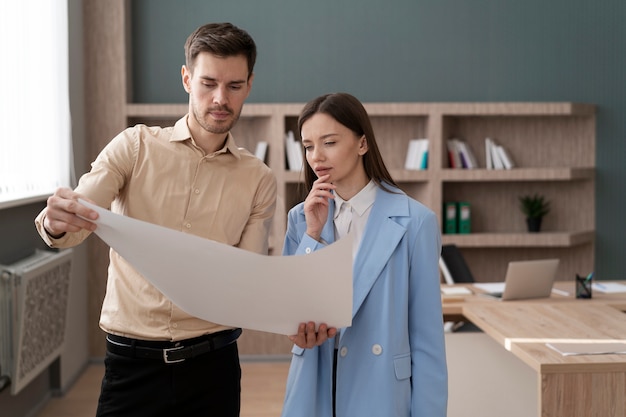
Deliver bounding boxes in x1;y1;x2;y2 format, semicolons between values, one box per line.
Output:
0;249;72;395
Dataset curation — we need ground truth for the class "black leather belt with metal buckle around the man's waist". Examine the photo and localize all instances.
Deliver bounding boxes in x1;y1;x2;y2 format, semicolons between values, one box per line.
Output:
106;329;241;363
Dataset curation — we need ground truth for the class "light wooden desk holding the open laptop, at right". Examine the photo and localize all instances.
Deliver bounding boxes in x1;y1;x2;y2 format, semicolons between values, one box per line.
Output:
444;283;626;417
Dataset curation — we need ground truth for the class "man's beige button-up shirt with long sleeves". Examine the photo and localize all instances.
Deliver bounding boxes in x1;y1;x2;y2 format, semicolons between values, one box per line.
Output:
35;116;276;341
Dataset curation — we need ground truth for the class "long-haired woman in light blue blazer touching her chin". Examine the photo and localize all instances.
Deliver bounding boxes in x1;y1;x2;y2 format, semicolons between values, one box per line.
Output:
283;93;448;417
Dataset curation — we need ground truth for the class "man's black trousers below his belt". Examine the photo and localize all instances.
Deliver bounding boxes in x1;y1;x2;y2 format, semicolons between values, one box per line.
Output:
96;342;241;417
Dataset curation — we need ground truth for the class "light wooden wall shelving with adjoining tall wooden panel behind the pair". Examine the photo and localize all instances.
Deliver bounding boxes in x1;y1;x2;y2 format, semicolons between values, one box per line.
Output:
83;0;596;357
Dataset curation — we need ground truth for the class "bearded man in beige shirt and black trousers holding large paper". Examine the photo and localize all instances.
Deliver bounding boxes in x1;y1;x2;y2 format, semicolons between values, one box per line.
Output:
35;23;276;417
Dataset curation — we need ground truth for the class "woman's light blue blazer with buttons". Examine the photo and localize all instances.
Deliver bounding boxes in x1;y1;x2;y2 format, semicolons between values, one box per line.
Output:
282;187;448;417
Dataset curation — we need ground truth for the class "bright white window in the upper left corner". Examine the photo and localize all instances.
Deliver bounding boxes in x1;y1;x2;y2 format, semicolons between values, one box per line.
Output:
0;0;71;208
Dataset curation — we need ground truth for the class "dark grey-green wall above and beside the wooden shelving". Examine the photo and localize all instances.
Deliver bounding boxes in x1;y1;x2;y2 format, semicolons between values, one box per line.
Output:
132;0;626;279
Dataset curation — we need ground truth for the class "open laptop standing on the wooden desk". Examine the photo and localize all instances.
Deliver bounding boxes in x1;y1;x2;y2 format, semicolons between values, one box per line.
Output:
474;259;559;301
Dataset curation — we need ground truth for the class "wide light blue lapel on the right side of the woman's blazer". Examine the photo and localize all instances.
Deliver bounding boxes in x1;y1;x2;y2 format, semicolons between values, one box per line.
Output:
352;188;409;317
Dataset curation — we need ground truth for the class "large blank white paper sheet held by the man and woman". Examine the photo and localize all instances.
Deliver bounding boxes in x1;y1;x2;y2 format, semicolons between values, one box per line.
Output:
80;200;352;335
